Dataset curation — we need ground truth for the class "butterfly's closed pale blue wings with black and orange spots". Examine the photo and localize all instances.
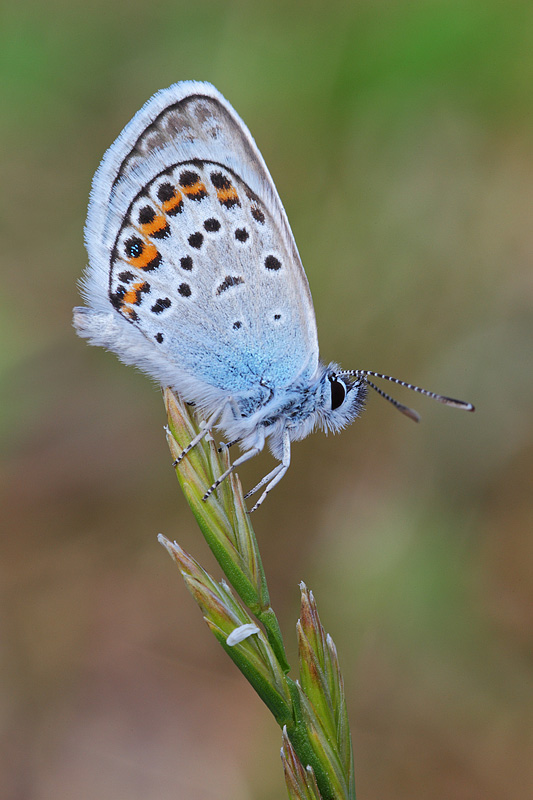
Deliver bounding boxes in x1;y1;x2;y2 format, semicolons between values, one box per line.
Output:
84;83;318;392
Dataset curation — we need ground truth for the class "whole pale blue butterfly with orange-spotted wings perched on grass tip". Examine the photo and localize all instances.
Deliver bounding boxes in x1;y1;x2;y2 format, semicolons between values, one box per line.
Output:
74;81;474;511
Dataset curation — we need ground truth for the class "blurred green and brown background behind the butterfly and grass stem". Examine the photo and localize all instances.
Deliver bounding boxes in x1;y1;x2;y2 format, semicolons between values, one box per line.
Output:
0;0;533;800
